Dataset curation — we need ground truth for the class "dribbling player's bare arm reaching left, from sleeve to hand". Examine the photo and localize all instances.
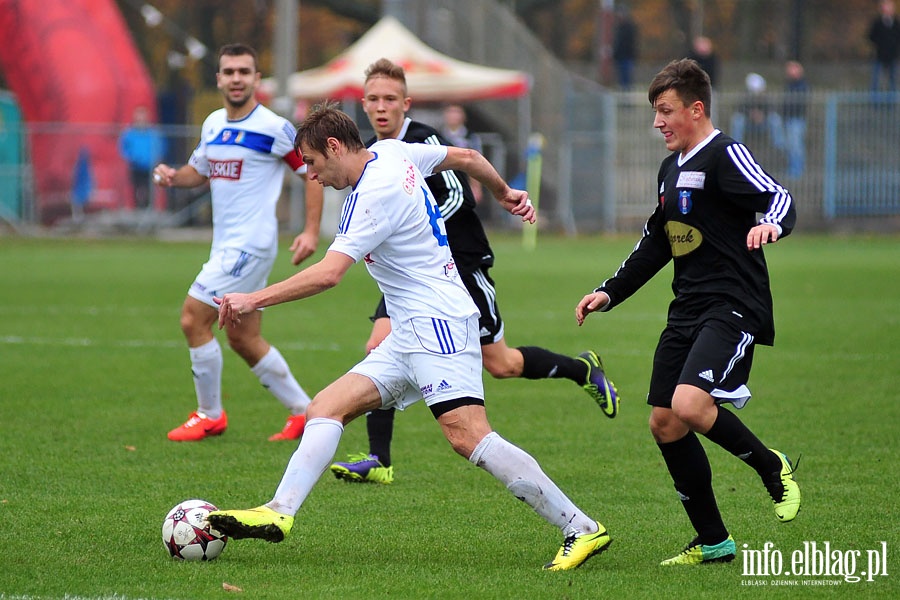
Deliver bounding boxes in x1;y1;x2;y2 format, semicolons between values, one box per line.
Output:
213;250;354;329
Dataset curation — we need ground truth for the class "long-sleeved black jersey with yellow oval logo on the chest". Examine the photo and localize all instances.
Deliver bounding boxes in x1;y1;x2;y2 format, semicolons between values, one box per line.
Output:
597;131;796;345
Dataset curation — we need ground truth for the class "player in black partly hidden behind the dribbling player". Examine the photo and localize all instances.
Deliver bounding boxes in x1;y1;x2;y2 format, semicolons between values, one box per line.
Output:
331;58;619;483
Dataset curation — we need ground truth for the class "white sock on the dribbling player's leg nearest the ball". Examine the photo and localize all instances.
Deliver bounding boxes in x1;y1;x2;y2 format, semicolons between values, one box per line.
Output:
266;417;344;516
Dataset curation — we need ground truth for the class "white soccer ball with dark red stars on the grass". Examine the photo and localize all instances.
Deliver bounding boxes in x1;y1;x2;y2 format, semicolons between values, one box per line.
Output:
163;500;228;560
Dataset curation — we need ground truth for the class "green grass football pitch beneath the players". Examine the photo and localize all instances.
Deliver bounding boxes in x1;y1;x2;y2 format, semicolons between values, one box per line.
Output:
0;234;900;600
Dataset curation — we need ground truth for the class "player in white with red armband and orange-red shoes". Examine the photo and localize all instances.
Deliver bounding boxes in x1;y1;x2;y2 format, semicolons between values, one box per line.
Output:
153;44;322;441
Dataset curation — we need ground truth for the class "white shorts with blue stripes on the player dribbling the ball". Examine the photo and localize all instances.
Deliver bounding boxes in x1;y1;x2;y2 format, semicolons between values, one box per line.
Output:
350;315;484;410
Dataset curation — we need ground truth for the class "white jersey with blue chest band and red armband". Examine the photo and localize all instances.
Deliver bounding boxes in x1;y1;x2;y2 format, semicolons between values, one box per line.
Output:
188;104;306;257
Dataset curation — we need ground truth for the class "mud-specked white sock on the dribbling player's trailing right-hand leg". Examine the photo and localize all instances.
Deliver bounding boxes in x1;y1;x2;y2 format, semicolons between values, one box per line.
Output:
469;431;599;537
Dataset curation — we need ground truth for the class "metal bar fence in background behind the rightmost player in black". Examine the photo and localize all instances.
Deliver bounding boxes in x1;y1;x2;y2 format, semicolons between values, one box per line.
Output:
556;92;900;233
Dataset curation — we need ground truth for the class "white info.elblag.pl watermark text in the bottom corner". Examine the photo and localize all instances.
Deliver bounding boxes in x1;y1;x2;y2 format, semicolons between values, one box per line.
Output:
741;542;888;586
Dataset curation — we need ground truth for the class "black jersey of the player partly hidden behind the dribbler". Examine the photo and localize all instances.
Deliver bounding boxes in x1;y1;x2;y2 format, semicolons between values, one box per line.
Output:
366;118;494;273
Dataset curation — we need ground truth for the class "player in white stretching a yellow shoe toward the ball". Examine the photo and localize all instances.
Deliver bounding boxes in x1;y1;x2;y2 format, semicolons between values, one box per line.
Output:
209;105;610;570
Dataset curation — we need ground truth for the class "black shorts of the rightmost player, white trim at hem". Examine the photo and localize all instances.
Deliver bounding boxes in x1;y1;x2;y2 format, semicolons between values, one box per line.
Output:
647;316;755;408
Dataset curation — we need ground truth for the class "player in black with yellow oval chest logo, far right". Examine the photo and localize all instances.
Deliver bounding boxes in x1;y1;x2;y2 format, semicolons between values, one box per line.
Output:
575;59;800;565
